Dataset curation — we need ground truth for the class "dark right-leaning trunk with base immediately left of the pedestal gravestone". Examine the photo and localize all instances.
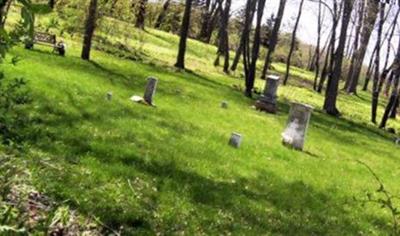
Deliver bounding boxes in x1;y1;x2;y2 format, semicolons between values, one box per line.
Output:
245;0;266;97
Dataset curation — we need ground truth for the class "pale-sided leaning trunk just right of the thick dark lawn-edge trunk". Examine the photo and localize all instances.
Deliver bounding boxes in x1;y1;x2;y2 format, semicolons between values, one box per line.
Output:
346;1;379;94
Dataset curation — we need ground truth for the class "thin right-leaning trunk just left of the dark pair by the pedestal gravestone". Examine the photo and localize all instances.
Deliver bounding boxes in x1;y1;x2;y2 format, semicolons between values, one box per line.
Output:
231;0;255;71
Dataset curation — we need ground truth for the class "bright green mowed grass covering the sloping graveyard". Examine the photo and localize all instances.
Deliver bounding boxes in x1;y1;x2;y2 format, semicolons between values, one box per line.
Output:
4;19;400;235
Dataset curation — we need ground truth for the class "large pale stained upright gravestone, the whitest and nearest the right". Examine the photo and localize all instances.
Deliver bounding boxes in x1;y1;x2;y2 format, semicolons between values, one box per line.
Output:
282;103;313;151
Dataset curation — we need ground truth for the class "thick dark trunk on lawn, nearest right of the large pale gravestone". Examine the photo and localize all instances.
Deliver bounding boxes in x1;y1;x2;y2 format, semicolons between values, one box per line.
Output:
324;0;353;116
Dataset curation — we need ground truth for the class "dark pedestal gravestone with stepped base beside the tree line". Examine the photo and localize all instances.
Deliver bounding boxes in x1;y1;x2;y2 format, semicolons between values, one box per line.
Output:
255;75;279;114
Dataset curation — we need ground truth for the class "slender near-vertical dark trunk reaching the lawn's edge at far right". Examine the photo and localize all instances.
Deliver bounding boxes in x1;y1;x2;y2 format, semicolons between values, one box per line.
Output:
371;3;385;123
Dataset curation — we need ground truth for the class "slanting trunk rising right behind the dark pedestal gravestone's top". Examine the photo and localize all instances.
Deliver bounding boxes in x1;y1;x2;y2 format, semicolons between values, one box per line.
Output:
261;0;286;79
